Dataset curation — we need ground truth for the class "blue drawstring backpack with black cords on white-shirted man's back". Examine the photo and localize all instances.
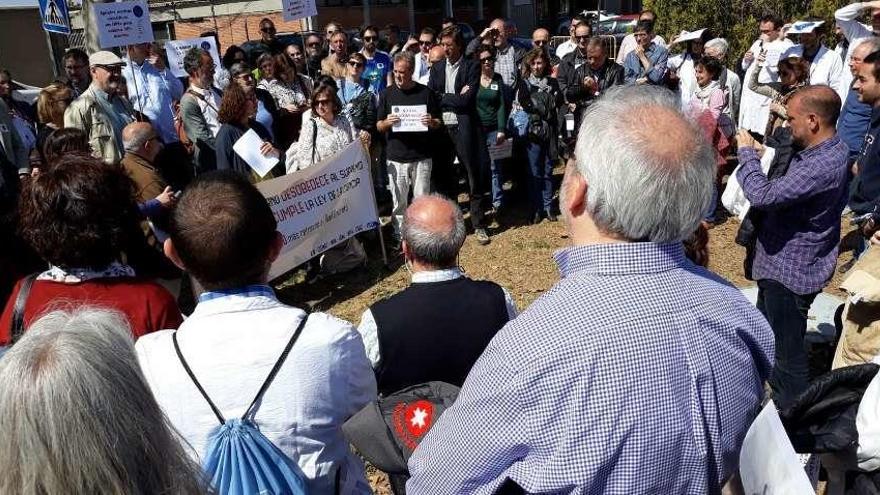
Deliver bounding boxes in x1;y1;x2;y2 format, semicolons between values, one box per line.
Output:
172;315;308;495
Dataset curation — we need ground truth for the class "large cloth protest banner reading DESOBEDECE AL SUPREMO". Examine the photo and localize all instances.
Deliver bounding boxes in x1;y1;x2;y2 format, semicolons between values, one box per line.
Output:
257;141;379;279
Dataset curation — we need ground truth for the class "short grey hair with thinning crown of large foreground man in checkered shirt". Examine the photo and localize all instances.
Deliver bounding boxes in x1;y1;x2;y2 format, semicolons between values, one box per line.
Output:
575;86;715;242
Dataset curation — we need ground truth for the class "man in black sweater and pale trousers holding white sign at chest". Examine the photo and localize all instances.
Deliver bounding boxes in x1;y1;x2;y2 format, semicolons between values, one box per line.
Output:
376;52;441;239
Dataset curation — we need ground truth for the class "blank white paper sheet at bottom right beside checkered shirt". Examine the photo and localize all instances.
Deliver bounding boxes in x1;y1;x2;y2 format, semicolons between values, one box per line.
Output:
739;401;815;495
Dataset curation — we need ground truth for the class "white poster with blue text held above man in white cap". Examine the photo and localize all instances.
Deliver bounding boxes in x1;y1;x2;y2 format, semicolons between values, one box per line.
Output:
92;0;153;48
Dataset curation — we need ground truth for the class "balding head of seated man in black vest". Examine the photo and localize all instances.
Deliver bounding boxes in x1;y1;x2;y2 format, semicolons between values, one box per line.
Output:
402;194;467;270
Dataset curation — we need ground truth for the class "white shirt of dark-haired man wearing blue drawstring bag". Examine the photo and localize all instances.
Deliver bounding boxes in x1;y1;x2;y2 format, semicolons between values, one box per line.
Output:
135;288;376;494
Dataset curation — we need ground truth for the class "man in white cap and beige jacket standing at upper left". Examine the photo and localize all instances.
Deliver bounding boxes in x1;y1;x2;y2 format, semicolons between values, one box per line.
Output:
64;51;134;165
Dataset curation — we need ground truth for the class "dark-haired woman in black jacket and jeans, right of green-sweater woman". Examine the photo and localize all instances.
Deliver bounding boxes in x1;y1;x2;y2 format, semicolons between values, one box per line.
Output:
517;48;564;224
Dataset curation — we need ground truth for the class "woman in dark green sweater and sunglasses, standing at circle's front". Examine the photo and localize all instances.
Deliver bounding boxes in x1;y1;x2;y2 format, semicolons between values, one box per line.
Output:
476;45;507;220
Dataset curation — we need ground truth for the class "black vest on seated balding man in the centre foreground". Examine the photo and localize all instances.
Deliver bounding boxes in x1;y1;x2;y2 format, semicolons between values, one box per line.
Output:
370;277;509;395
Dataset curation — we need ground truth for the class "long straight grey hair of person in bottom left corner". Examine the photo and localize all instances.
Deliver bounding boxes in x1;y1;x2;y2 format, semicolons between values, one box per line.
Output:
0;307;207;494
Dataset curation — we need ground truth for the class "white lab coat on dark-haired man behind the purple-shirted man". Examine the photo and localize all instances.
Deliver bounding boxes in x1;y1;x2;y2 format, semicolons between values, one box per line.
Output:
739;39;793;134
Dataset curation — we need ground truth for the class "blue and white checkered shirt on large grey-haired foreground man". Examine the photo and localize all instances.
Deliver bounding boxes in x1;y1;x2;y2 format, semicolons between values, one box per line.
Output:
406;243;774;495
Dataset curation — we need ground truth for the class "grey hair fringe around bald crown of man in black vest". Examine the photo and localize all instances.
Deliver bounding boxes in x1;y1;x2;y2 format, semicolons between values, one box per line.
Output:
401;193;467;268
